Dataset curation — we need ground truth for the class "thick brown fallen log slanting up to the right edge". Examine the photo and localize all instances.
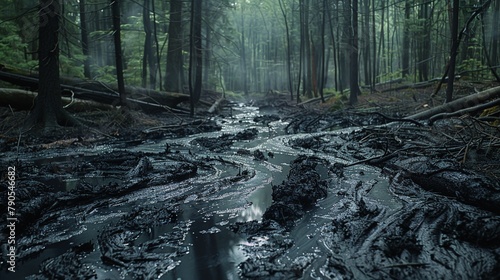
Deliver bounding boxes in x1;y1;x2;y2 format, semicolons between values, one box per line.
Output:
405;87;500;120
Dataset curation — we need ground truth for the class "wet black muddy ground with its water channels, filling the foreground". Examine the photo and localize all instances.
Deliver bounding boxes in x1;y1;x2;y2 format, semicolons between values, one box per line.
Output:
0;88;500;279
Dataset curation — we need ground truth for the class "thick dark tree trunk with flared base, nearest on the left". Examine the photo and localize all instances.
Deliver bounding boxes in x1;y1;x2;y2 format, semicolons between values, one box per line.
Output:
26;0;78;129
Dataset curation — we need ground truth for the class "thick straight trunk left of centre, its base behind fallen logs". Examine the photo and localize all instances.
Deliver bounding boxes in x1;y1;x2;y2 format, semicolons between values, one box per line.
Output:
164;0;184;92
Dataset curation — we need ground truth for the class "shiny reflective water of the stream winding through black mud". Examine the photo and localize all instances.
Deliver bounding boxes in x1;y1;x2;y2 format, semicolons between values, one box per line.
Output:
0;107;400;279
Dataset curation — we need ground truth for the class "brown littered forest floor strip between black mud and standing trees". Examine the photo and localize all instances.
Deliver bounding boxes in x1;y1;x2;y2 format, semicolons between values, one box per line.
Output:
0;82;500;179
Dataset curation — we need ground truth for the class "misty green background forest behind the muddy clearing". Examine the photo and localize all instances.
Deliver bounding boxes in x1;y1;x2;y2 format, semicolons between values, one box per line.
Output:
0;0;500;111
